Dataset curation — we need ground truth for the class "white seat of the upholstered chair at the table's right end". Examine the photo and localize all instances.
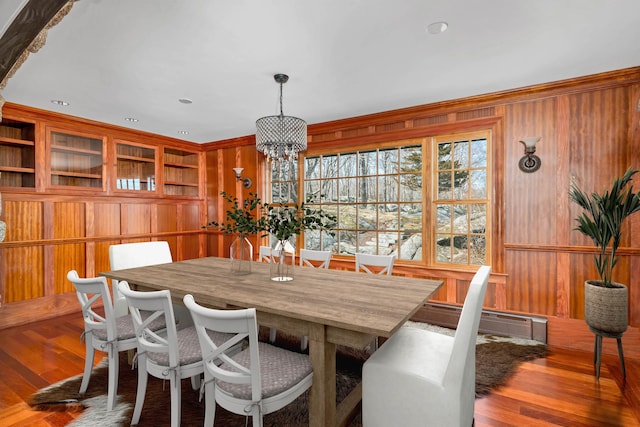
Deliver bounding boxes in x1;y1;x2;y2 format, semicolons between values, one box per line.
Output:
365;327;453;384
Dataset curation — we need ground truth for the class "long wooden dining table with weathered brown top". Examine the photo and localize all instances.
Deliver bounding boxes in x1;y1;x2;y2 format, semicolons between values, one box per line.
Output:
100;257;442;427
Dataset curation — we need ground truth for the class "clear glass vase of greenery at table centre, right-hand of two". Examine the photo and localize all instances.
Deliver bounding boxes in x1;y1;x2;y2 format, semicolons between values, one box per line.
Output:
260;199;336;281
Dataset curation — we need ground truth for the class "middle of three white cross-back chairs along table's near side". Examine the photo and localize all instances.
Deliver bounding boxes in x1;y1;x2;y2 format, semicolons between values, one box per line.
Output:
118;281;229;427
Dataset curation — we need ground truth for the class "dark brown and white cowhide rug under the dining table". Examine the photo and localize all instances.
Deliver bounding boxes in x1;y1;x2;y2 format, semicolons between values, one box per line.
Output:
29;322;547;427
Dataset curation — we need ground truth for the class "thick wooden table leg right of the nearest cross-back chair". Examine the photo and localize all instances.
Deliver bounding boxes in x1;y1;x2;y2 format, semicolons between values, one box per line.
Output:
309;324;336;427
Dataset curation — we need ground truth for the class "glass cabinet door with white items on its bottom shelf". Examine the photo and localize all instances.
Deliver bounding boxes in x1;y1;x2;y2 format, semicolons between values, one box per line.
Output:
116;141;157;192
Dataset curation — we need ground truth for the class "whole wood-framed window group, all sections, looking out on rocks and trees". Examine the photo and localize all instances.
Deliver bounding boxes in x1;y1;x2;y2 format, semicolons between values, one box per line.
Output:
270;130;491;267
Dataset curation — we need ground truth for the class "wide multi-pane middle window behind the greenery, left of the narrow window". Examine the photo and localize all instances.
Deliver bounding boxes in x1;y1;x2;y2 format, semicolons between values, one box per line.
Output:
303;140;423;260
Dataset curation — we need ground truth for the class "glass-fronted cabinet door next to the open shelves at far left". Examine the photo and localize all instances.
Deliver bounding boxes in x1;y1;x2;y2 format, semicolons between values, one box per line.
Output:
48;130;106;191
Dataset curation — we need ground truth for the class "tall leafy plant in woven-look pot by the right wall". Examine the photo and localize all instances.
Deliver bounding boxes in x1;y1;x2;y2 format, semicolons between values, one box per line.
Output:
569;168;640;335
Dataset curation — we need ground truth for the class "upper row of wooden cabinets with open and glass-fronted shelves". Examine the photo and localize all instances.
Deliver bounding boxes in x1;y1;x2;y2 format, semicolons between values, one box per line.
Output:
0;117;203;198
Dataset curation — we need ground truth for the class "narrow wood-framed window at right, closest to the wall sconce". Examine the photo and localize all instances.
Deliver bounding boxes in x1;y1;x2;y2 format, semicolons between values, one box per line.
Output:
432;131;491;265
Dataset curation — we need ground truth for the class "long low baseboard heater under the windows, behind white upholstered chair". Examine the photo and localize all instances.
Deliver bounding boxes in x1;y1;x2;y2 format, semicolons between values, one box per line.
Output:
420;303;547;344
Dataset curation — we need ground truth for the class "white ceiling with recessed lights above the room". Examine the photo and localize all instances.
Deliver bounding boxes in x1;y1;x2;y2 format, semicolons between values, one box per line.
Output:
0;0;640;143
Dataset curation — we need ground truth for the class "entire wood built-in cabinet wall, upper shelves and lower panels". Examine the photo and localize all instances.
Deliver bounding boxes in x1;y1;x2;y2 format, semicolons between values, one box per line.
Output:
0;103;207;315
